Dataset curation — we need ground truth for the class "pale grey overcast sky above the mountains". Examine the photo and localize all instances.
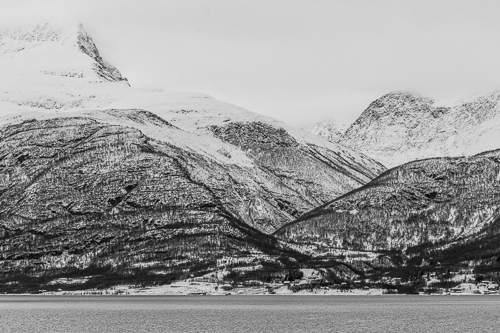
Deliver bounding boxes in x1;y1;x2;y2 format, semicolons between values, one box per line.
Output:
0;0;500;126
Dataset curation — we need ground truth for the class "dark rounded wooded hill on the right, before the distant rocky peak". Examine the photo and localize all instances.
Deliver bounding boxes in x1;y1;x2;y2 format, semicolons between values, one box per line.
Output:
276;150;500;267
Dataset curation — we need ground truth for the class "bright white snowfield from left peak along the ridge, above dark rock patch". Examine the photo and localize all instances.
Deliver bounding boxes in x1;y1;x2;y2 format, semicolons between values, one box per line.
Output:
0;21;376;167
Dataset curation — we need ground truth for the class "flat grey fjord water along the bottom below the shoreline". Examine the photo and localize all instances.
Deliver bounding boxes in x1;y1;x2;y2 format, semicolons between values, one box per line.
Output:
0;295;500;333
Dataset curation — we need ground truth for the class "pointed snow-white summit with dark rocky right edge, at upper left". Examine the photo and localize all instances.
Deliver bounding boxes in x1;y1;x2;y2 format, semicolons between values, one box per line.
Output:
0;20;129;115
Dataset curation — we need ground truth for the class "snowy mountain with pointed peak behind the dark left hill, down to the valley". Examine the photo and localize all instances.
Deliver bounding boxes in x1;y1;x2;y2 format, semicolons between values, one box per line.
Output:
0;22;385;231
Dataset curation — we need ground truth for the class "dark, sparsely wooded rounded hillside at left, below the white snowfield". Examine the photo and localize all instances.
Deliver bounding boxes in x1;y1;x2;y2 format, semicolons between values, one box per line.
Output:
0;110;294;288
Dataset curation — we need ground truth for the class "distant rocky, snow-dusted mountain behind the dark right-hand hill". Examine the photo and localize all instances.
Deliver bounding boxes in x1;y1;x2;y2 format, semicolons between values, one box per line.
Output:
340;91;500;167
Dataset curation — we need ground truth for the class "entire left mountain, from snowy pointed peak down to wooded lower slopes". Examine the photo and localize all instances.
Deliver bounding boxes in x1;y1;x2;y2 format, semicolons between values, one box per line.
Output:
0;22;385;290
